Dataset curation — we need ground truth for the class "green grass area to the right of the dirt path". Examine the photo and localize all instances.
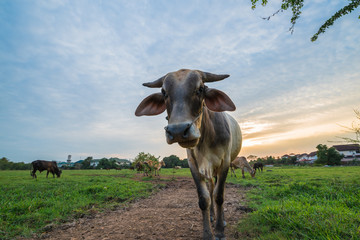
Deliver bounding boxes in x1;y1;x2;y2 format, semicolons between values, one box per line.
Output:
228;167;360;239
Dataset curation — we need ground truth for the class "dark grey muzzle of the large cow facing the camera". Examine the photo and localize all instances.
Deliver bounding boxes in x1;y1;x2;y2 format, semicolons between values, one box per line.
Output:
165;122;201;148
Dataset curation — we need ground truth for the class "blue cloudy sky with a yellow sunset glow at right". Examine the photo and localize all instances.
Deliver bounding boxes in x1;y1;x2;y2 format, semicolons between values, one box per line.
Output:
0;0;360;162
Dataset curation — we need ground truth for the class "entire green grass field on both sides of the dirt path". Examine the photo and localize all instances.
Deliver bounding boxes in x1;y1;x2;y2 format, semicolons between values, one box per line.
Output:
0;167;360;239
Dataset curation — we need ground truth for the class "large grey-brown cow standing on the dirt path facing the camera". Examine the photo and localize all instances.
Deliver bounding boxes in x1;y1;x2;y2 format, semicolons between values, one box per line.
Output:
135;69;242;239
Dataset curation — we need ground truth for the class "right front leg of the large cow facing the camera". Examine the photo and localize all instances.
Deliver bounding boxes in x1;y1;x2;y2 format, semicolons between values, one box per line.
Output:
214;168;229;239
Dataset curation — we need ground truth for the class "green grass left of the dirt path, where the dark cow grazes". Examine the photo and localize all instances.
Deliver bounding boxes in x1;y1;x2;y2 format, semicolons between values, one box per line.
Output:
0;170;157;239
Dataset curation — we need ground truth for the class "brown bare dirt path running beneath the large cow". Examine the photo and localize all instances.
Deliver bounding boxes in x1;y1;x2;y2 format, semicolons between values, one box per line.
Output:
37;178;250;240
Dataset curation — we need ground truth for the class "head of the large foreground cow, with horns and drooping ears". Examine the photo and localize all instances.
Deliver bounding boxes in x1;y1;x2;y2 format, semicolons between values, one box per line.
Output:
135;69;235;148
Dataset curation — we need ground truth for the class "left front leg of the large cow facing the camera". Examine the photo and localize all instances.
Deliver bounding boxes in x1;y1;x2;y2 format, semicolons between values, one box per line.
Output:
189;161;214;240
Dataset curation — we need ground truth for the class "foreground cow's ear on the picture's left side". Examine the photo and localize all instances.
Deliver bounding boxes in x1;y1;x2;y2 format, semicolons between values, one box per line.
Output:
135;93;166;117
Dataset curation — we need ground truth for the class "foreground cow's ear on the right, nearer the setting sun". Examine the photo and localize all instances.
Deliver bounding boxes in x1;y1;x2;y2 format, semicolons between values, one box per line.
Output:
205;88;236;112
